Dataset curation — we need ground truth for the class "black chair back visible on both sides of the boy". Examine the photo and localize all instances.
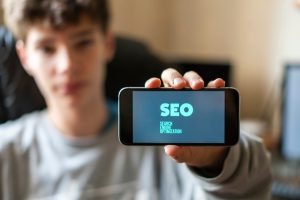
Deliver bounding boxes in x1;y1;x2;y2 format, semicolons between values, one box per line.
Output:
0;27;165;123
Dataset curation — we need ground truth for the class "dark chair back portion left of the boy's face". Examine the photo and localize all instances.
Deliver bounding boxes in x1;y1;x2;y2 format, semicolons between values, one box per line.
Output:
0;27;45;123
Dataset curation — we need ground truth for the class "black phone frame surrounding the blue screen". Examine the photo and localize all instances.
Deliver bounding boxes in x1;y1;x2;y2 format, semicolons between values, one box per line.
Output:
118;87;240;146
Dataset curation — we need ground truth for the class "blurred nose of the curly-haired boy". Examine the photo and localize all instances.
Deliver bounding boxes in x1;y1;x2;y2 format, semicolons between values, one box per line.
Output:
57;47;76;73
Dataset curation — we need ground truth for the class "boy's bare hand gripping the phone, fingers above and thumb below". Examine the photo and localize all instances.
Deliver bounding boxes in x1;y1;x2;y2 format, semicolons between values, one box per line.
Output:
145;68;228;173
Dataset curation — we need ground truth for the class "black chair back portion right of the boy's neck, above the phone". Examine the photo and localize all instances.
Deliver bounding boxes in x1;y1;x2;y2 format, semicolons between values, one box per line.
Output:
106;37;167;100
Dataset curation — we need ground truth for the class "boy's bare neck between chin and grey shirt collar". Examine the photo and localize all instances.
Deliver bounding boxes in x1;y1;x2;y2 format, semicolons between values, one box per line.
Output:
48;97;108;138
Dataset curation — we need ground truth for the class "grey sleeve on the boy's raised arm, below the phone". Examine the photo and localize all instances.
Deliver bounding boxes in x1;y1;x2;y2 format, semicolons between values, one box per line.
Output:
192;130;272;200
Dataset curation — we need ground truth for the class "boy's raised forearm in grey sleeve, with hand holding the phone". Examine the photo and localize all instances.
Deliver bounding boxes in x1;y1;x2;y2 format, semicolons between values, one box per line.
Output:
146;69;271;199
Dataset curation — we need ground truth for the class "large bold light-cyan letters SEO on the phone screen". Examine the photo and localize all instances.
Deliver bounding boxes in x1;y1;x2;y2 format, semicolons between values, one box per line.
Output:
160;103;194;117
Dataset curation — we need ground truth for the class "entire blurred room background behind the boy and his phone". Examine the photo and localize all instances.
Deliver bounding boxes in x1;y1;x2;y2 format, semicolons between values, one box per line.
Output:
0;0;300;200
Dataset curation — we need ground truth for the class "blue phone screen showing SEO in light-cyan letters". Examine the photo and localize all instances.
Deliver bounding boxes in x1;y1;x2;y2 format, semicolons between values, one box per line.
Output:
133;91;225;143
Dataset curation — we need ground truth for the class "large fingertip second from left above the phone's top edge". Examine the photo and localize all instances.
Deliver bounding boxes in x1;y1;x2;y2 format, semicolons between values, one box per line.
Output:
161;68;186;89
